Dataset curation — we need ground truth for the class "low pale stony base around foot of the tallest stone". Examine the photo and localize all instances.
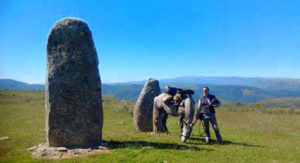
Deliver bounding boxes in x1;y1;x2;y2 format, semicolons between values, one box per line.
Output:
27;143;109;159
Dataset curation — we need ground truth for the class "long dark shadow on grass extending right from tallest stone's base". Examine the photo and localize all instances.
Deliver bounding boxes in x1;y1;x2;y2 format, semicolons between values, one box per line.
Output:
107;140;213;151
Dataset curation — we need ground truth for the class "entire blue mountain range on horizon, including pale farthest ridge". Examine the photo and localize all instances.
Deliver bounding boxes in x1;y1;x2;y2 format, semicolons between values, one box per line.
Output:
0;77;300;102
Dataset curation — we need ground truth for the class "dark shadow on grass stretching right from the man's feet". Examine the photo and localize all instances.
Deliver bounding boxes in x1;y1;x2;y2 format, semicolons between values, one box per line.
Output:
188;137;266;147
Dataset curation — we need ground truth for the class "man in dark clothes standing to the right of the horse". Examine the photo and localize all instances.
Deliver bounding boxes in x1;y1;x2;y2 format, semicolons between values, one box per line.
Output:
197;87;223;144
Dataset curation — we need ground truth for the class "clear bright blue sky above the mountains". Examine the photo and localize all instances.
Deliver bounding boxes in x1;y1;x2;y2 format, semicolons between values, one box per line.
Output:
0;0;300;83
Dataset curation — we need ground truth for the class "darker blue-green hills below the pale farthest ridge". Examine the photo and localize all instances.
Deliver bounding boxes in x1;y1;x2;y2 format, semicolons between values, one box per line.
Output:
0;79;300;102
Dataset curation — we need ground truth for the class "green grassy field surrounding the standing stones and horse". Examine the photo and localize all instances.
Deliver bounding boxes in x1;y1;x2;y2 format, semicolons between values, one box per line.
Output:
0;91;300;162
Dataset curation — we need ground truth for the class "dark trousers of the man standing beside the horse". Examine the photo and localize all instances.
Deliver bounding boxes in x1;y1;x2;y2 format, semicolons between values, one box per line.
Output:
203;113;223;143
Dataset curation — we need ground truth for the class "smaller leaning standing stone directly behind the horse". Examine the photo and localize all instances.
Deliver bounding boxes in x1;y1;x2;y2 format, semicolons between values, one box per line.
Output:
133;78;160;132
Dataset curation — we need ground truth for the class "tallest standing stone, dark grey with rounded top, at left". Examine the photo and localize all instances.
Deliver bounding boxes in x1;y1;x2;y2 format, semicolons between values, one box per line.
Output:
45;18;103;147
